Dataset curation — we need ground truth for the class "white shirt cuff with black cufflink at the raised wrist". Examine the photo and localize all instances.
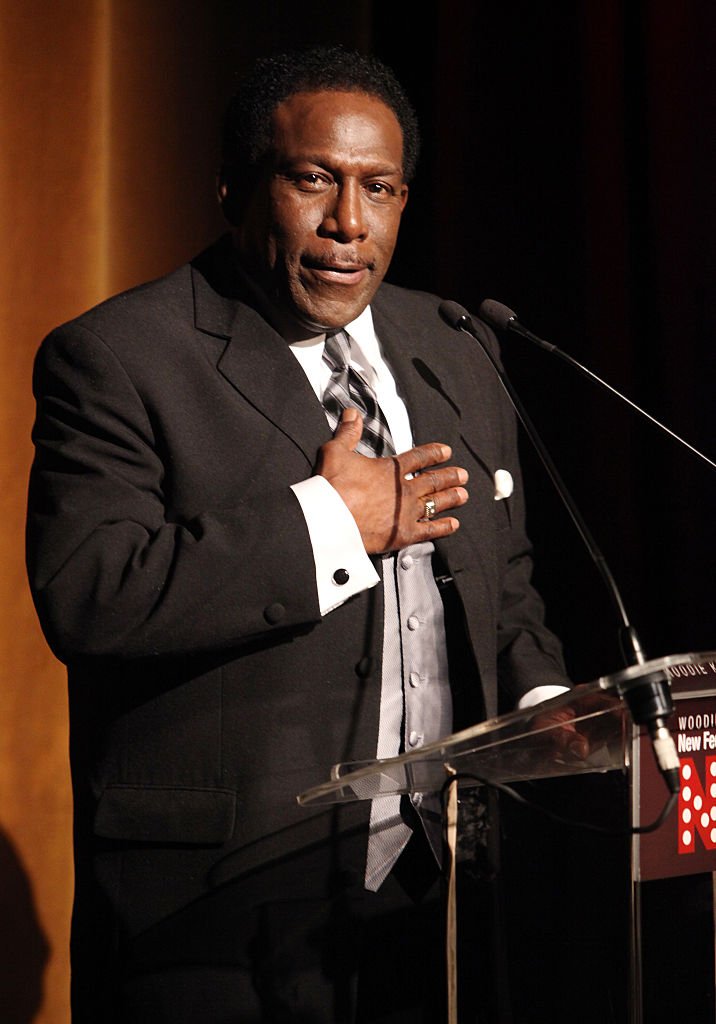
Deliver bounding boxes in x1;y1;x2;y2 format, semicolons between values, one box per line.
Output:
291;476;380;615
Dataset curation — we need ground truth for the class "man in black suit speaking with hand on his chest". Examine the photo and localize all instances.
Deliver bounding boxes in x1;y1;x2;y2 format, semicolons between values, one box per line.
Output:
28;50;565;1024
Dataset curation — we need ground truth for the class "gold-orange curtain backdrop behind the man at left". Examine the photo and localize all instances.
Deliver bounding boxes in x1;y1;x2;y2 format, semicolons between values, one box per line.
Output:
0;6;229;1024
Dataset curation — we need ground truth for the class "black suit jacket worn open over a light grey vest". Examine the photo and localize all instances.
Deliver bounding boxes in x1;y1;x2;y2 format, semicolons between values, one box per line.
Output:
28;232;564;941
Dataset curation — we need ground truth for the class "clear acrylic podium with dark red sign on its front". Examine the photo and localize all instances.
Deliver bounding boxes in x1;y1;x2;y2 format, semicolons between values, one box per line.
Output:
298;653;716;1024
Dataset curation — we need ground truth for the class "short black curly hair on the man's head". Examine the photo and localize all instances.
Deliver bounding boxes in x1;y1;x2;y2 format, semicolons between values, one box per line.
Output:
221;46;420;181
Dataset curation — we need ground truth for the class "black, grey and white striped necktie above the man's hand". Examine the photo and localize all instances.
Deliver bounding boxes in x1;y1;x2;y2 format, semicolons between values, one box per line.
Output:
323;331;395;457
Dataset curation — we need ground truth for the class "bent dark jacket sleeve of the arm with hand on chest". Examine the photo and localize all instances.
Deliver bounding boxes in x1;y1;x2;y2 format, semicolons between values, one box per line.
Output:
27;323;320;659
